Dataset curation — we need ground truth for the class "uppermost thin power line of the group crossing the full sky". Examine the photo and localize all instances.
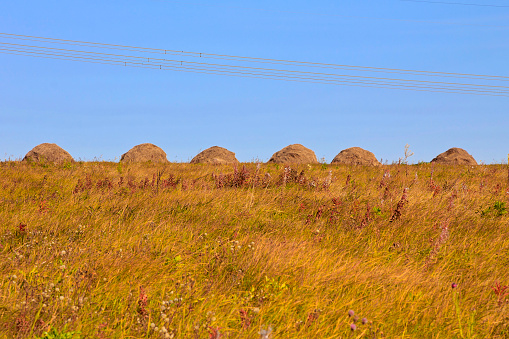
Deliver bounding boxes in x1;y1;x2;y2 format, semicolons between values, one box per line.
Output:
0;32;509;81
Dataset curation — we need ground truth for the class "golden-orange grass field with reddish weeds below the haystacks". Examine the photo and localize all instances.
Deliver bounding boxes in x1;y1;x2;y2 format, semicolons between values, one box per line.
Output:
0;161;509;339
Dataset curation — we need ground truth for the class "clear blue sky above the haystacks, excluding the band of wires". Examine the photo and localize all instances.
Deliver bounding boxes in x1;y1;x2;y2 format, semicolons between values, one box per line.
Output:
0;0;509;163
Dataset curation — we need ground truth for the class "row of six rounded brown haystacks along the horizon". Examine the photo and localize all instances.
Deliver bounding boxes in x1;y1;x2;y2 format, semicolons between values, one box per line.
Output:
23;143;477;166
